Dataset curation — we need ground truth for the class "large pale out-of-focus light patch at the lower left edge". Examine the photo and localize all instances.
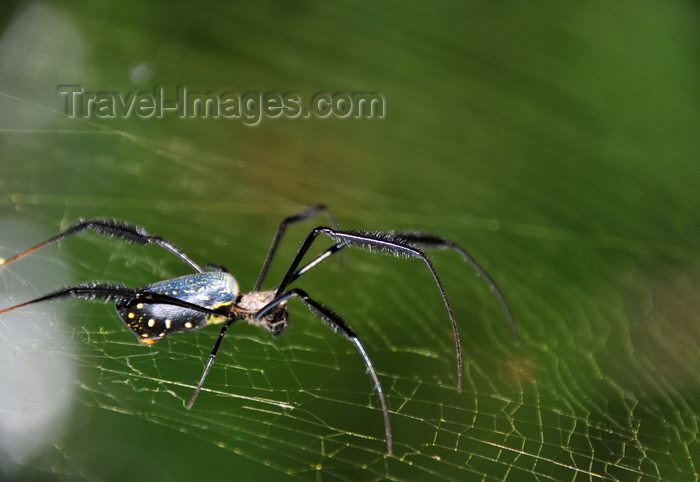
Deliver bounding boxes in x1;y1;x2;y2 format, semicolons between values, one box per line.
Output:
0;220;77;474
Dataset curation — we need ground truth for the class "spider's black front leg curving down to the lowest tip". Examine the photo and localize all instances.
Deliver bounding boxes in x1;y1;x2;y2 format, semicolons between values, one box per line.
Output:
255;288;393;455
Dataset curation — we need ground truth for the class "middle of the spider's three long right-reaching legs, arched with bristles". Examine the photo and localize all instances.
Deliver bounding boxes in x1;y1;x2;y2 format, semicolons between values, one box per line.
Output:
276;226;462;392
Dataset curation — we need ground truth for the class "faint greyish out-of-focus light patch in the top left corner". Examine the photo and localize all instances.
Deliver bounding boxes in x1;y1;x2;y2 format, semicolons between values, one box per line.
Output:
0;2;85;129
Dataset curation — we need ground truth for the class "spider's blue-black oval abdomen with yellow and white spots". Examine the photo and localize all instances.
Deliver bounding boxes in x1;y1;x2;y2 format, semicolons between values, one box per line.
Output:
115;272;238;345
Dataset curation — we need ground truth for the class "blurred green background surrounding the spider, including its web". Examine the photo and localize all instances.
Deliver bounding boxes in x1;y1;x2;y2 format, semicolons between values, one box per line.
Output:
0;0;700;480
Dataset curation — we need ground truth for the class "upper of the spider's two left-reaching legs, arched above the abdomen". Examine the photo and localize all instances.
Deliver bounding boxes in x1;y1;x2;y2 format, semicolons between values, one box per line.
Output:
0;219;204;273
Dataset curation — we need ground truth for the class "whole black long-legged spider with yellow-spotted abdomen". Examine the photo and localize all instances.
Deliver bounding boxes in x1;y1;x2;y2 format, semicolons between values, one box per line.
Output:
0;205;518;455
